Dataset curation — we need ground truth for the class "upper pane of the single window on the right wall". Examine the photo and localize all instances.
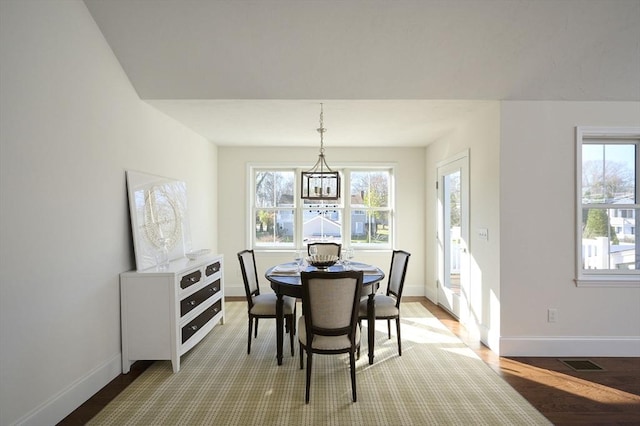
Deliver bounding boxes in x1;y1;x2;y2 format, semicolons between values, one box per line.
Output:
582;144;637;204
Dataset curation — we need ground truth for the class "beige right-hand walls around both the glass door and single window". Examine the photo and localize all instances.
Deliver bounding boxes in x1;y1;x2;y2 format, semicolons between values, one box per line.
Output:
425;102;640;356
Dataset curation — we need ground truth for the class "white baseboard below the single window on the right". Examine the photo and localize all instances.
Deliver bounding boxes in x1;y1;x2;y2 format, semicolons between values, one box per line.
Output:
500;336;640;357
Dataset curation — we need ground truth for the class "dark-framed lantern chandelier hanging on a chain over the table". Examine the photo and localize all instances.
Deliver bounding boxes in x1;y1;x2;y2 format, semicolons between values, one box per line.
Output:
302;104;340;200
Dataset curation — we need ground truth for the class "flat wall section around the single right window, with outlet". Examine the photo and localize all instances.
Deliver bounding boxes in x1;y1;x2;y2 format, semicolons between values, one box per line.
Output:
500;102;640;356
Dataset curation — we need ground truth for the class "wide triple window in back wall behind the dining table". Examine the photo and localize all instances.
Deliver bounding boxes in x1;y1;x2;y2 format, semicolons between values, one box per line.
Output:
250;166;393;250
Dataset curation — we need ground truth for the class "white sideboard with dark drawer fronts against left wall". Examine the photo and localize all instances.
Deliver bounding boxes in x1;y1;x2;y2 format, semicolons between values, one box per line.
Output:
120;255;224;374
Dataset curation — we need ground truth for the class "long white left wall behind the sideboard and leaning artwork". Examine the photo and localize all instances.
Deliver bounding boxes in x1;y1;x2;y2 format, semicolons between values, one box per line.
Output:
0;0;217;425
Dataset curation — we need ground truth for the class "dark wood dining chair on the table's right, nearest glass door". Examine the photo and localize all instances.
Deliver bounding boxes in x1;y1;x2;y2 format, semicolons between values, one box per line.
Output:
358;250;411;356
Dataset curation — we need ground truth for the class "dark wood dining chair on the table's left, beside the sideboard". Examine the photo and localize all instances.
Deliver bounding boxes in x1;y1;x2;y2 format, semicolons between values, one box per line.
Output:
238;250;296;356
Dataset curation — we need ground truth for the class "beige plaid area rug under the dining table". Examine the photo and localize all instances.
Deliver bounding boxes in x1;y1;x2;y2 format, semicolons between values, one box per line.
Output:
89;302;550;426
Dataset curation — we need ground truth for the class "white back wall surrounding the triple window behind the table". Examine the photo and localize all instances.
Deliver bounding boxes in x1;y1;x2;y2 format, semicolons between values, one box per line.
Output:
218;145;425;296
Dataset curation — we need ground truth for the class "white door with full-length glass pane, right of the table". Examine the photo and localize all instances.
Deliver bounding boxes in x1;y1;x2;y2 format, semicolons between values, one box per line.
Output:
436;151;469;322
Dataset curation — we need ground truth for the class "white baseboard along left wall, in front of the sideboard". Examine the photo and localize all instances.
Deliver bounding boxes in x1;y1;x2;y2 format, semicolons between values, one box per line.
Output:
13;353;122;426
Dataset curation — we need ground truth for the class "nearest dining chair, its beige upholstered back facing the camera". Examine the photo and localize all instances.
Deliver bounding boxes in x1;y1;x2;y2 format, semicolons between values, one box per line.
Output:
298;271;363;404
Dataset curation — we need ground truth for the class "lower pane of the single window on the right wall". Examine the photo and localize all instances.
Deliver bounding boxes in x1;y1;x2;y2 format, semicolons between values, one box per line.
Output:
582;208;640;270
